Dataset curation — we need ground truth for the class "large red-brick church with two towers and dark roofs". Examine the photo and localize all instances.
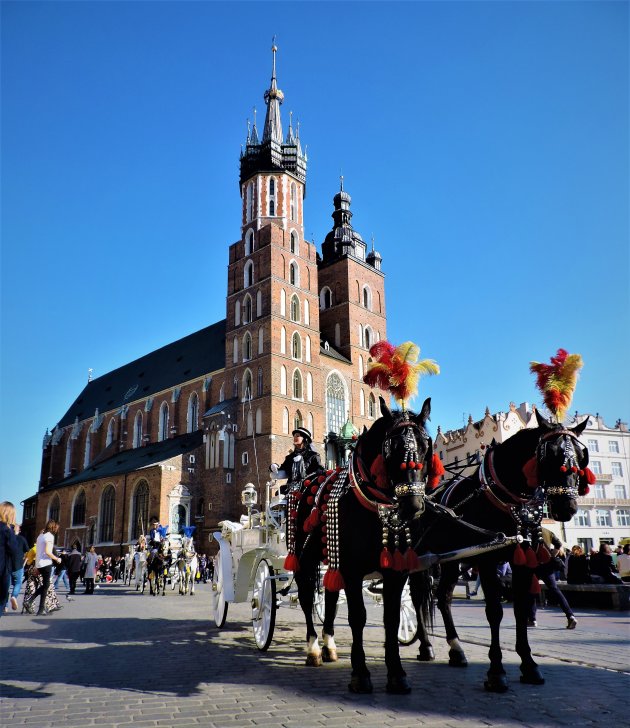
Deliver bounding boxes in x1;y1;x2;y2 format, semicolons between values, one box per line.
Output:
24;46;386;555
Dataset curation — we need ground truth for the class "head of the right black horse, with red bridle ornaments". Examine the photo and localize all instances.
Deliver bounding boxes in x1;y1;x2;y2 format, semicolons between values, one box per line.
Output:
536;410;588;521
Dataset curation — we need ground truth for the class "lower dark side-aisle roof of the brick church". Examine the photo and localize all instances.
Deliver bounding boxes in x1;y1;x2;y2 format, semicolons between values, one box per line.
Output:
48;430;203;487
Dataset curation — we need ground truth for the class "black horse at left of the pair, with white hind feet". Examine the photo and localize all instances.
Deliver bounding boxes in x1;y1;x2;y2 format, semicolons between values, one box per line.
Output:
288;398;440;693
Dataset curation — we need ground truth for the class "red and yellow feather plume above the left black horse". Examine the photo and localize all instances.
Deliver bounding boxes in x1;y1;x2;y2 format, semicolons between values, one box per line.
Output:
363;341;440;409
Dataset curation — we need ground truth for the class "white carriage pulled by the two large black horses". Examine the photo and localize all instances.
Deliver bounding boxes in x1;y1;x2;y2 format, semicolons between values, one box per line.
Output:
212;481;418;651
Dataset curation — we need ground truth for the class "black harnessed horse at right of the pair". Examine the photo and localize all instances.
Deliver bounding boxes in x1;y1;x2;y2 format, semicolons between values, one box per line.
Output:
411;411;589;692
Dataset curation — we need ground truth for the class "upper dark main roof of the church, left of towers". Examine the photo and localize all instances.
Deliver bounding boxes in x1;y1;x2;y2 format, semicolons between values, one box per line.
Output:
58;319;225;427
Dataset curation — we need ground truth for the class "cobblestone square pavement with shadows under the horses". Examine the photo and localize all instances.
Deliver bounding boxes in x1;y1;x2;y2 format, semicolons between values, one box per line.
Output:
0;585;630;728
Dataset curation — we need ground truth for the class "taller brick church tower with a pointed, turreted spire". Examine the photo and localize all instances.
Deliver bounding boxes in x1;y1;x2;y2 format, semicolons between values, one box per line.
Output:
224;44;324;487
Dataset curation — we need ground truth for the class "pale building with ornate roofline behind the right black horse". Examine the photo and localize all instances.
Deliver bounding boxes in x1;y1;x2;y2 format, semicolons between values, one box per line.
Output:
435;402;630;552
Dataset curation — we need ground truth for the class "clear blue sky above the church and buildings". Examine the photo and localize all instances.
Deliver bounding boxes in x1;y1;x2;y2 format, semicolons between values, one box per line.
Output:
0;2;630;520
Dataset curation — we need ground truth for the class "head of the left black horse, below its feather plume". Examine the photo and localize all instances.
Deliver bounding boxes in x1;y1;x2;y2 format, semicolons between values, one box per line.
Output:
360;397;433;518
